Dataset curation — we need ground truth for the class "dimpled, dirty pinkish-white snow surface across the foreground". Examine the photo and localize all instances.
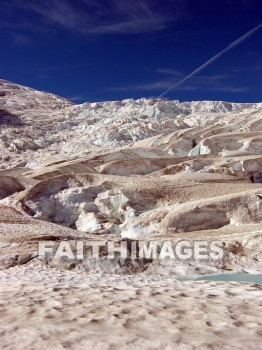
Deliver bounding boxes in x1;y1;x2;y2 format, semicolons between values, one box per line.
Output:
0;261;262;350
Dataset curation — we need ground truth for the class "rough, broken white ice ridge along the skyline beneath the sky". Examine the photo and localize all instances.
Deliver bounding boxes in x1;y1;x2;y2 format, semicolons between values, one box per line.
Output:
0;80;262;167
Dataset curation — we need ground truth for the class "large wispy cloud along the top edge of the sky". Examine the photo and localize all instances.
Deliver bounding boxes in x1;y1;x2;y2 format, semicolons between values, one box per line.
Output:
7;0;187;34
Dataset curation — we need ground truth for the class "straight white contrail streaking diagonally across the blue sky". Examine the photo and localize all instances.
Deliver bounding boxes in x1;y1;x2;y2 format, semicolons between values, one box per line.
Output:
158;23;262;98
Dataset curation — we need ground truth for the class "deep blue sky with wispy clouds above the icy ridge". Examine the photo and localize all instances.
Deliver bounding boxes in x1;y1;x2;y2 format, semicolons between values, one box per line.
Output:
0;0;262;103
